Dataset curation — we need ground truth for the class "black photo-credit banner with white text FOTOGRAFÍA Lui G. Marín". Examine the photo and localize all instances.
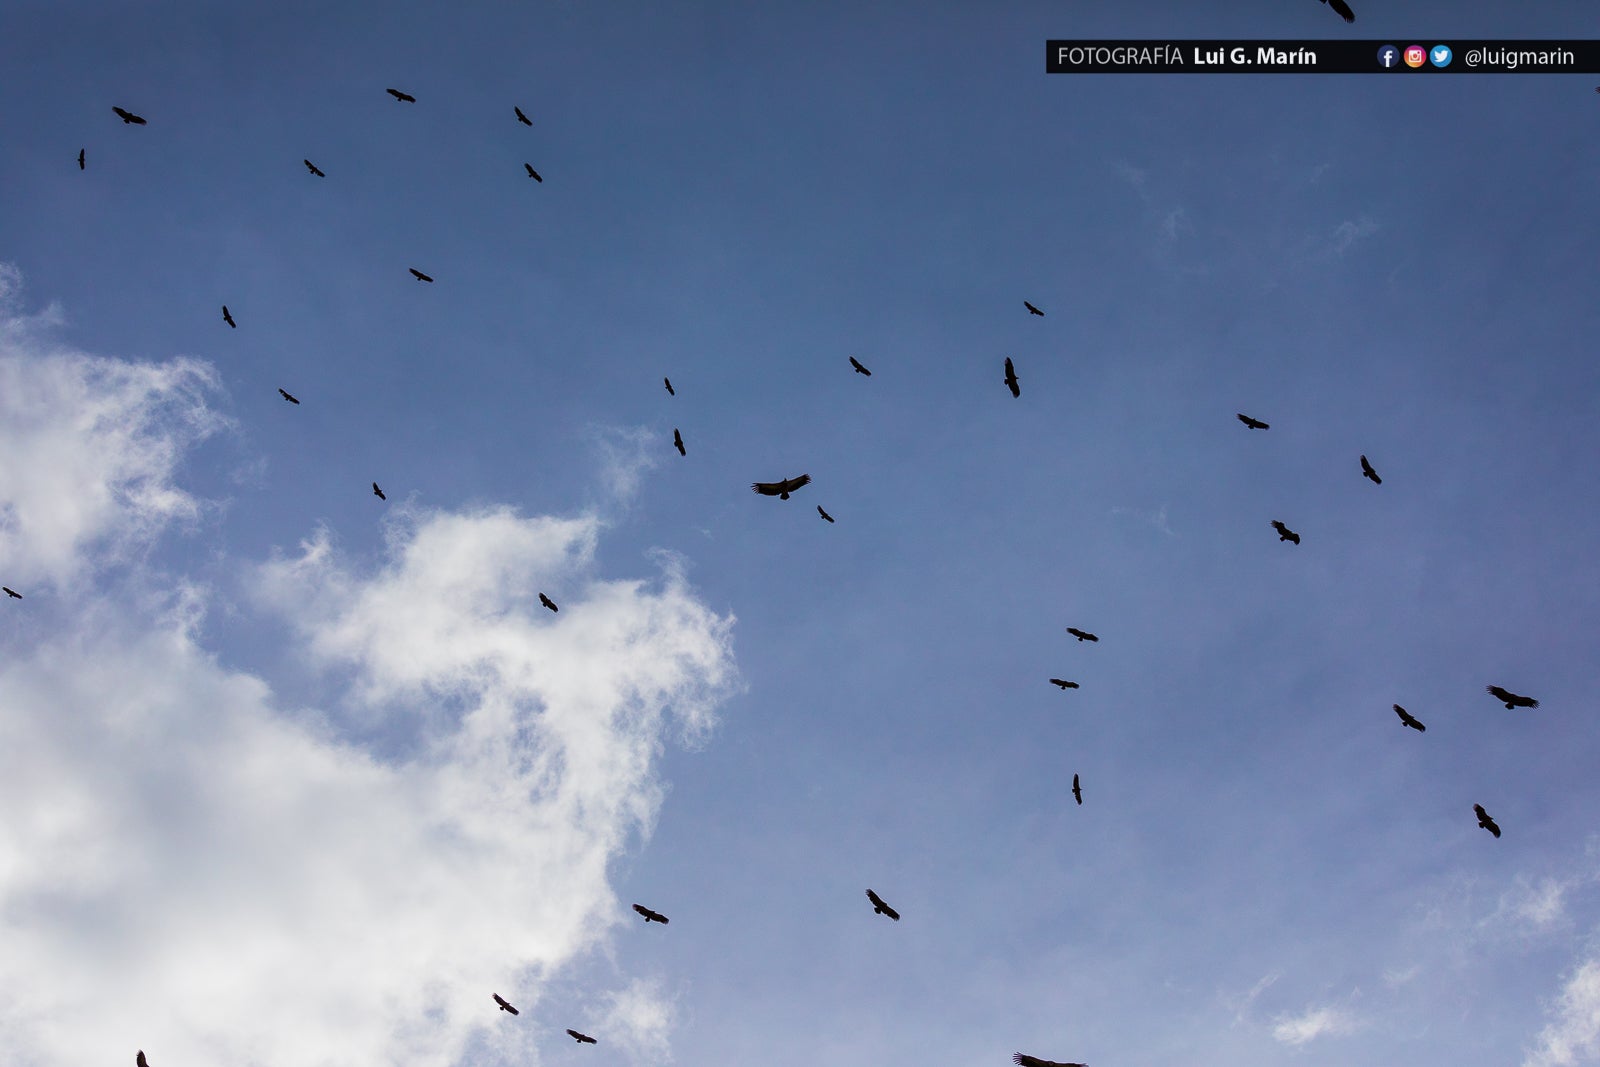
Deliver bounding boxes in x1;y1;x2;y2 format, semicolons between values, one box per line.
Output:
1045;38;1600;75
